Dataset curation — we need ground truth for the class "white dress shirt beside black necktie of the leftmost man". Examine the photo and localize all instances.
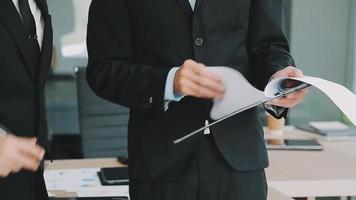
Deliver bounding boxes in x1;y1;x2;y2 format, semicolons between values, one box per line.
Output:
12;0;44;48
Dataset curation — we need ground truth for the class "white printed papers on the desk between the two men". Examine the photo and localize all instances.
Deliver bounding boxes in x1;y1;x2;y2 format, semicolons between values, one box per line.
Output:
44;168;129;198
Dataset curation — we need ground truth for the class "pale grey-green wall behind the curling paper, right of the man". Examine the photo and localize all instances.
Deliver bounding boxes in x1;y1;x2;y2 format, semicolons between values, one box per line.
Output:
290;0;355;124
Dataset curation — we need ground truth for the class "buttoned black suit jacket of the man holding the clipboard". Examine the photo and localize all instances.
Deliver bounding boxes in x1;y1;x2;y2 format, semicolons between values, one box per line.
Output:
87;0;294;180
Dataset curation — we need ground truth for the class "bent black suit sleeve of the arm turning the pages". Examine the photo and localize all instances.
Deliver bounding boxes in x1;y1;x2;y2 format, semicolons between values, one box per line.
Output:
87;0;171;112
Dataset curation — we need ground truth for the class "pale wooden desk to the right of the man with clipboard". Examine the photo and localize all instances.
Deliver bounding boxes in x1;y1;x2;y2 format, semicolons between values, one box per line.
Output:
266;129;356;197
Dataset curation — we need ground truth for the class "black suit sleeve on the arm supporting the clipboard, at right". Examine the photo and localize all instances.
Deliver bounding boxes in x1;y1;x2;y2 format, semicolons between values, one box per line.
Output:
248;0;295;119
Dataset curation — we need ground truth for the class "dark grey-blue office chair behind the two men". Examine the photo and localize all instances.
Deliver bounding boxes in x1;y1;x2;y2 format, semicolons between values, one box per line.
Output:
75;67;129;158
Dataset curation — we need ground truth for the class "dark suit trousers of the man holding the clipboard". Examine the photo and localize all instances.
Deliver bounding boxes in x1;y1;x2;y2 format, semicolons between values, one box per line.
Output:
130;135;267;200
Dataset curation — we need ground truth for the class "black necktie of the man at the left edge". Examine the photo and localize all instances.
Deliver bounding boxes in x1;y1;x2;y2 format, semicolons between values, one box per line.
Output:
19;0;41;76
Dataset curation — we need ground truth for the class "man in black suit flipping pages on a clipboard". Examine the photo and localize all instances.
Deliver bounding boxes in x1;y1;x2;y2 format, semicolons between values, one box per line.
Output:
87;0;306;200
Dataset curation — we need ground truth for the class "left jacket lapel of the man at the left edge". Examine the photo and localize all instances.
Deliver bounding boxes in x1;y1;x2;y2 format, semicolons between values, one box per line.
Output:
0;0;32;77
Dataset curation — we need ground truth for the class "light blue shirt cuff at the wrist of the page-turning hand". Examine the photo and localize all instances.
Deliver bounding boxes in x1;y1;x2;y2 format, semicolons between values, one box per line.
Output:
164;67;184;110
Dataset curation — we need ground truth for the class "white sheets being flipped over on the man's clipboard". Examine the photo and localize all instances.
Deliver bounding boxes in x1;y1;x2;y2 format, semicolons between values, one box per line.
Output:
209;67;356;125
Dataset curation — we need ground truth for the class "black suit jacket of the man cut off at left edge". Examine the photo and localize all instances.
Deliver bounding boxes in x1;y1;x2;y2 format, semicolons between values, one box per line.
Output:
0;0;52;200
